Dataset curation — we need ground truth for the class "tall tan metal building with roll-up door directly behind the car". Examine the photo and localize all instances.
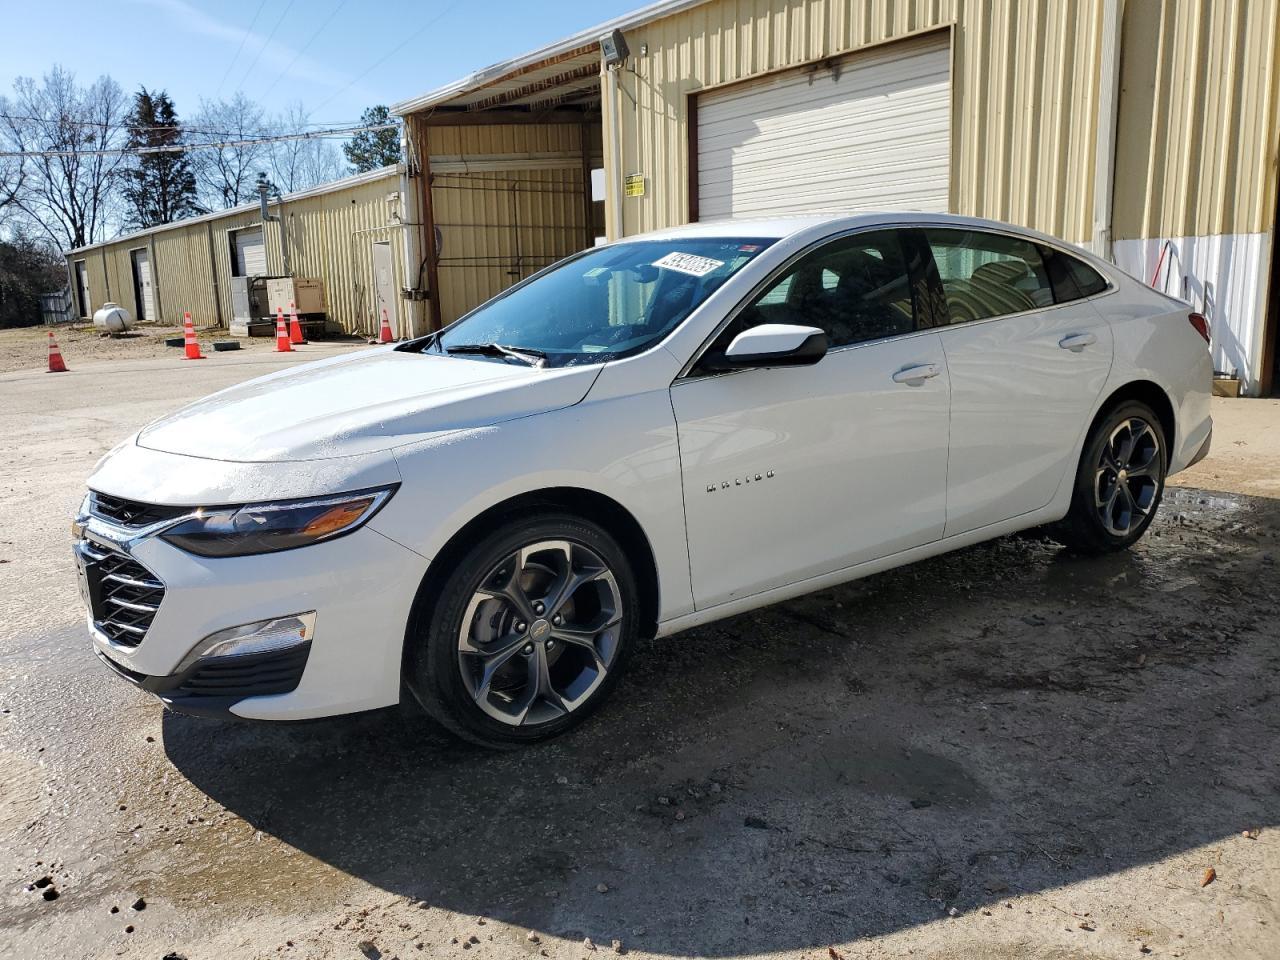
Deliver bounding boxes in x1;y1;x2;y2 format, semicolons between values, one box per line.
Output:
393;0;1280;394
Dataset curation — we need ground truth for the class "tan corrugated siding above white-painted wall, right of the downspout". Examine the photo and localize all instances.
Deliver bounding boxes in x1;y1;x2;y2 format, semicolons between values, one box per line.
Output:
1115;0;1280;239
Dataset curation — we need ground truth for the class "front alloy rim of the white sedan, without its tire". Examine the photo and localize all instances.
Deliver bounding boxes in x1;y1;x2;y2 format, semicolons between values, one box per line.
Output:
458;540;622;726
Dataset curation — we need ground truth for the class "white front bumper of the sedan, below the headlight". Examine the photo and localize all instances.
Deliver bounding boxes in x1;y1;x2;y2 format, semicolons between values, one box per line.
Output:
77;520;426;719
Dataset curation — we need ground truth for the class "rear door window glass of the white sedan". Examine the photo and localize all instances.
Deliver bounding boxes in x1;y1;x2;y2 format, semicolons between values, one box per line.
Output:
924;229;1055;324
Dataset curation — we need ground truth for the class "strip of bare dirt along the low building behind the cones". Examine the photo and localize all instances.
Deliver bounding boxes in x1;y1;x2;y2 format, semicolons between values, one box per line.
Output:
0;324;358;374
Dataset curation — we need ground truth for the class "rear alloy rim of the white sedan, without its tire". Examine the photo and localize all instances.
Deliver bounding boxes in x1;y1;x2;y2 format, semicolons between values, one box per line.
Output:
1093;417;1161;538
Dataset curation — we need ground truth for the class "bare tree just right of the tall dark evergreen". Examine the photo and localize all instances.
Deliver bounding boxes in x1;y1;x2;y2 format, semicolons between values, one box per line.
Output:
191;92;271;210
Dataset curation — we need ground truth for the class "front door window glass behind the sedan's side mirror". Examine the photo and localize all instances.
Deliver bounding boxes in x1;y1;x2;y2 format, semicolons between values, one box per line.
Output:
714;230;915;349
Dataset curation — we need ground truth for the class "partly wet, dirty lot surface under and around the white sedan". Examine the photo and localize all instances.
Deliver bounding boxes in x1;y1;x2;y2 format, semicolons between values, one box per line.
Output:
0;355;1280;960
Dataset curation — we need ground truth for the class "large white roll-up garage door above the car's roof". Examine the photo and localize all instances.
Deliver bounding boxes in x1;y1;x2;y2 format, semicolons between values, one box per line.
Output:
695;33;951;220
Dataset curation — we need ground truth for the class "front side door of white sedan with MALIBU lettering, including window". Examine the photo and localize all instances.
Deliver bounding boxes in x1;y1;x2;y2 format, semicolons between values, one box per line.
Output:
671;230;948;609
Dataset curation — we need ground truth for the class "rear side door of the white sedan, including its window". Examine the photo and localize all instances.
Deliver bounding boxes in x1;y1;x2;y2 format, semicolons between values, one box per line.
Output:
923;228;1112;536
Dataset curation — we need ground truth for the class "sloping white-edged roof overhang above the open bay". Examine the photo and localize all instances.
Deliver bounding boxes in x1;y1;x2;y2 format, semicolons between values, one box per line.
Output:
392;0;709;116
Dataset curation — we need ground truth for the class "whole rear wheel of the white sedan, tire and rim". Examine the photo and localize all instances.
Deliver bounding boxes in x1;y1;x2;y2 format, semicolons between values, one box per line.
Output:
1052;401;1169;554
